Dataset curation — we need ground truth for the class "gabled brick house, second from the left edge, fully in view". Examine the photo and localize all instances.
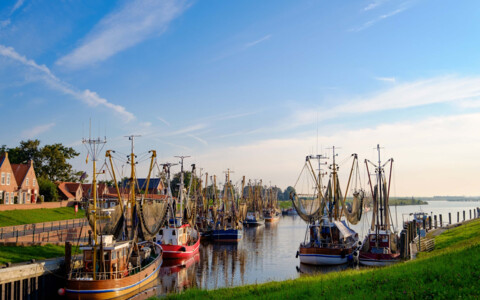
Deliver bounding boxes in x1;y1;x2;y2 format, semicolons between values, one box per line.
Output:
11;160;39;204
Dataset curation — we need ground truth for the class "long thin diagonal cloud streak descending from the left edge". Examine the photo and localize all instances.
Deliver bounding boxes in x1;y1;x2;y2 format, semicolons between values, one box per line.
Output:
0;45;135;121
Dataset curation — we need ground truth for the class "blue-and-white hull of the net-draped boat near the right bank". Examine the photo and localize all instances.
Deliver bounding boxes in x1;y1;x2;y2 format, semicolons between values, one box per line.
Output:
298;247;353;266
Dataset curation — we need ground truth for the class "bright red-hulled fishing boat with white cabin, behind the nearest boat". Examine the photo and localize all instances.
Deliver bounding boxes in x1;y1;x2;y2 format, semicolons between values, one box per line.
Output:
156;156;200;259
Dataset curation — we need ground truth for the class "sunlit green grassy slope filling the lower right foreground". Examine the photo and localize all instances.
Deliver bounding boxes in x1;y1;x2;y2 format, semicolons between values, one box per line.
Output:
164;220;480;299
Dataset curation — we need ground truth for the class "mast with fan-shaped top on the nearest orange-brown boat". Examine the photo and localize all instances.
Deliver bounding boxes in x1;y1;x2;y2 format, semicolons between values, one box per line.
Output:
82;135;107;280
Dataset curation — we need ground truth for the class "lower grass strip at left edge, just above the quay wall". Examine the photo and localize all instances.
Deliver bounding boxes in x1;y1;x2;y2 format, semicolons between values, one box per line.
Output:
0;244;73;264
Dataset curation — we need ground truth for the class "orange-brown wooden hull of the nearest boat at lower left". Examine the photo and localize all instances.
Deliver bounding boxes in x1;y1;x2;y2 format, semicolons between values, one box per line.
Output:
65;245;163;300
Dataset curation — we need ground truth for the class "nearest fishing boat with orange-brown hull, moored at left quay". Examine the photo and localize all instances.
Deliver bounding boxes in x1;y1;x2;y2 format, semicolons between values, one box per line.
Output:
64;136;166;299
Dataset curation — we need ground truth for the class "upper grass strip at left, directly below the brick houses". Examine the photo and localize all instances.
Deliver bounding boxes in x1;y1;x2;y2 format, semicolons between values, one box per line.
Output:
0;207;85;227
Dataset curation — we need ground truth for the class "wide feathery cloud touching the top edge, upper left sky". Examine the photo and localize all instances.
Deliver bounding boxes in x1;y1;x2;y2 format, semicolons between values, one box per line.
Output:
57;0;188;68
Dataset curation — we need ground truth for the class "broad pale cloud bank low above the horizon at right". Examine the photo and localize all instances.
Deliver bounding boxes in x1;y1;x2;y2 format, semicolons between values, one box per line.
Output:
196;113;480;196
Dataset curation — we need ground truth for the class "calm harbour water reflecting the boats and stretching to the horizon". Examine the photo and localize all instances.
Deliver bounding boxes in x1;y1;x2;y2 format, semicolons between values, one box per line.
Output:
138;201;480;298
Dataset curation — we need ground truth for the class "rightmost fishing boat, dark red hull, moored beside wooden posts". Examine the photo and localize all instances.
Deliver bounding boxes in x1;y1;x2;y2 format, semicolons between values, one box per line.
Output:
358;145;400;266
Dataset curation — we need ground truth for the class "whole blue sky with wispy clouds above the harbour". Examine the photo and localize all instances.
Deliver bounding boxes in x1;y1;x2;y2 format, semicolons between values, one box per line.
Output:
0;0;480;197
